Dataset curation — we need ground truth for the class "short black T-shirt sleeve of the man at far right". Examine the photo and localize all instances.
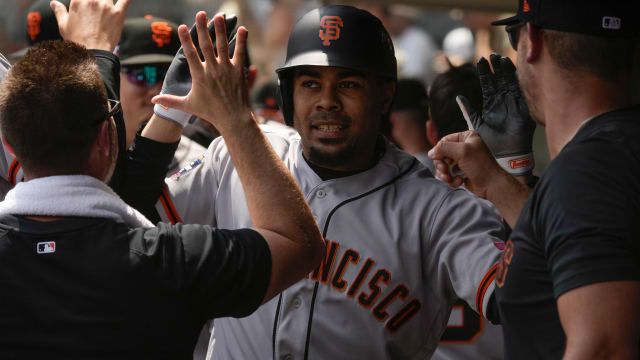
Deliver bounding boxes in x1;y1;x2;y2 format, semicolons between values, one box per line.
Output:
534;139;640;297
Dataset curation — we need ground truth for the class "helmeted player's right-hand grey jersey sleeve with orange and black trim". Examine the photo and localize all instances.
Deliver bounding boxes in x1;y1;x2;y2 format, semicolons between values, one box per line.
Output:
425;189;506;316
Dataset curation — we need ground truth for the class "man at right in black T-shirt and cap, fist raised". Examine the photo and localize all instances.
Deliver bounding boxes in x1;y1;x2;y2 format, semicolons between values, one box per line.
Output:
432;0;640;359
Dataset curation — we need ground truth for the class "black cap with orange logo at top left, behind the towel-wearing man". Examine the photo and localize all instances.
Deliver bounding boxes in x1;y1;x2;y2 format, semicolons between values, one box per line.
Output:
9;0;71;60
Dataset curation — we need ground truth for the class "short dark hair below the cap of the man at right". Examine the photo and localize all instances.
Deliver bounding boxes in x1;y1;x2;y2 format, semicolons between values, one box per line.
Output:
543;29;638;82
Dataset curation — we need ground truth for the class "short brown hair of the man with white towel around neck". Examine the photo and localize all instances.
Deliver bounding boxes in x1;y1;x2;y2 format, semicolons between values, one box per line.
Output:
0;40;109;174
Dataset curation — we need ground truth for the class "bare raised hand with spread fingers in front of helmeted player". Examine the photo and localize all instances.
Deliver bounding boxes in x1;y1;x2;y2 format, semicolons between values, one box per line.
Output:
152;12;254;135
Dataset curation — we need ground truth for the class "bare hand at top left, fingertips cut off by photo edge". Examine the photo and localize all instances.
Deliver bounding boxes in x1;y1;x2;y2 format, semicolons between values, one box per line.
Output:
51;0;131;51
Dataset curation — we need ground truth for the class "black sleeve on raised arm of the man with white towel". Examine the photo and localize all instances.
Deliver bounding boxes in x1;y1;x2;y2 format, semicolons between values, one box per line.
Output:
131;223;271;319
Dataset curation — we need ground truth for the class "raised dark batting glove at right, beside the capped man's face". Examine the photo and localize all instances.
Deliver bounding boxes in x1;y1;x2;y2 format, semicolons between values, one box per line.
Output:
459;54;536;175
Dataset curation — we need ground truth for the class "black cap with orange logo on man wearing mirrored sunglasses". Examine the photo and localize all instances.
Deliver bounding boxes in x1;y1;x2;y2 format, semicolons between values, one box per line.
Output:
114;16;180;66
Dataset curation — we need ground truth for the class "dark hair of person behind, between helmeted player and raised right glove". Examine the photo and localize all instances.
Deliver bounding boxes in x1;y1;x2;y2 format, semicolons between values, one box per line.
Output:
429;64;482;139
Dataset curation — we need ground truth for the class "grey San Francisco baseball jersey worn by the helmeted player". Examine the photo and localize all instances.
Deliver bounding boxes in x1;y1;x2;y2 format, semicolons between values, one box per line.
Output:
157;122;504;360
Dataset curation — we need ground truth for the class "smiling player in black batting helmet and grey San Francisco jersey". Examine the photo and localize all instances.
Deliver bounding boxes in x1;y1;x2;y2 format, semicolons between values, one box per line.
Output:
148;6;510;359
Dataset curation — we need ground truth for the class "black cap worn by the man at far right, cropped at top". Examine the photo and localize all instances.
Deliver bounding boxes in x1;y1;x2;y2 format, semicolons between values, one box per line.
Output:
492;0;640;38
